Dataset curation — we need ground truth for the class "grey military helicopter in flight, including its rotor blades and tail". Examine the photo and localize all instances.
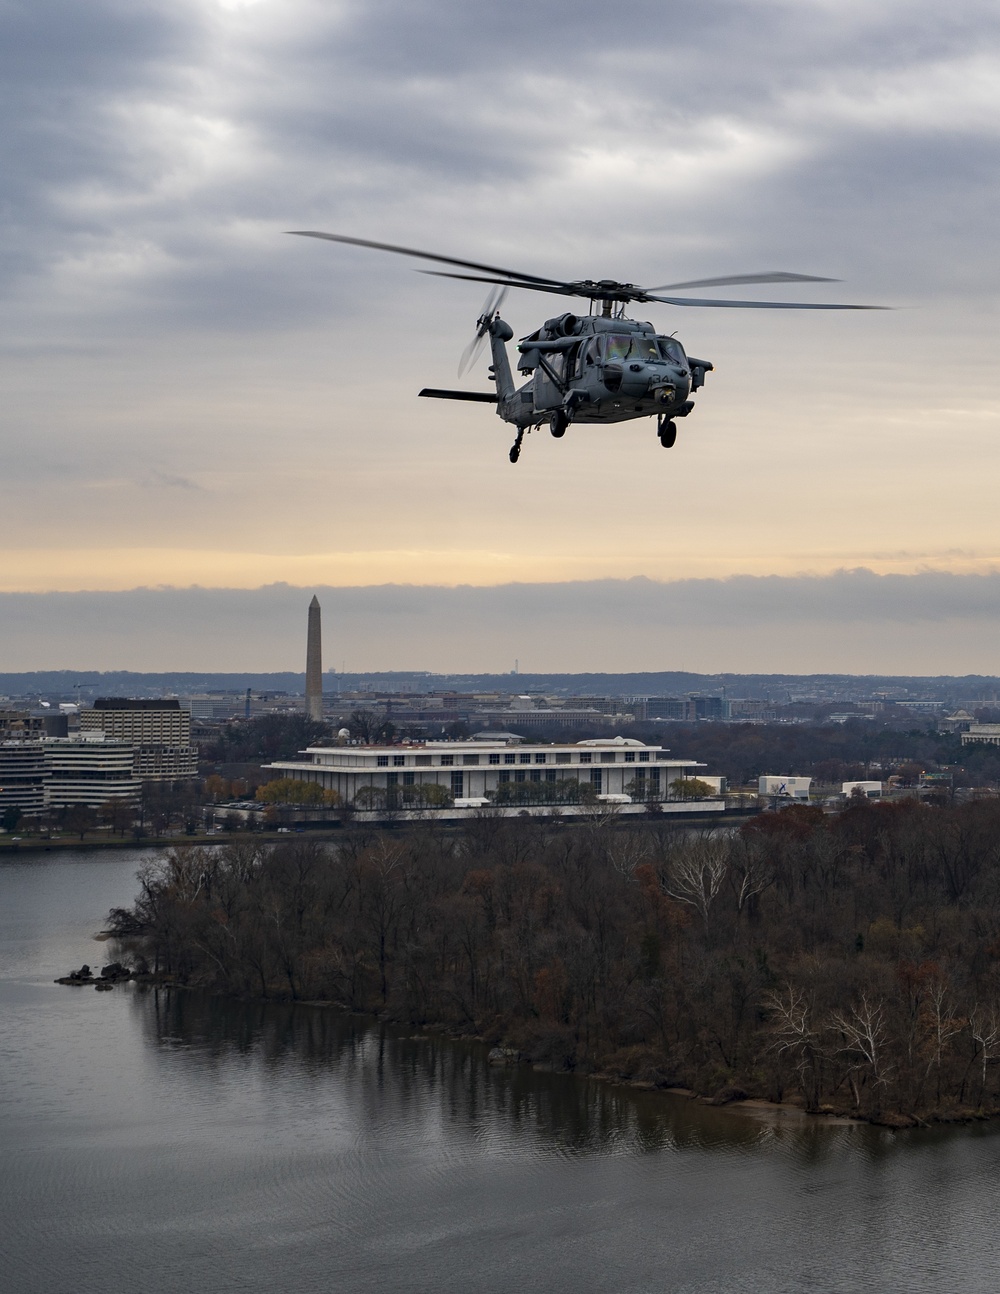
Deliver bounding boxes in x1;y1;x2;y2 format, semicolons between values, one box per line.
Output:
288;229;885;463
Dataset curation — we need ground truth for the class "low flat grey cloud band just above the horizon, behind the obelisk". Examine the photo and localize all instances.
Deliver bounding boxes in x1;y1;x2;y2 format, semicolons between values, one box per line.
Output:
0;571;1000;674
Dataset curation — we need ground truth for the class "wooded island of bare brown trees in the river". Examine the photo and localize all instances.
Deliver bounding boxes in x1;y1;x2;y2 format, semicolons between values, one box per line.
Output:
111;801;1000;1122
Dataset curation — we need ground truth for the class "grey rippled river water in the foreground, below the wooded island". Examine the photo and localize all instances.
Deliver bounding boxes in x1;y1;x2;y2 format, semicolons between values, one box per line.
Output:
0;853;1000;1294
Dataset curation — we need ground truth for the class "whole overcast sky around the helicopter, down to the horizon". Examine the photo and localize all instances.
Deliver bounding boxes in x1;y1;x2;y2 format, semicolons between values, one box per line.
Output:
0;0;1000;673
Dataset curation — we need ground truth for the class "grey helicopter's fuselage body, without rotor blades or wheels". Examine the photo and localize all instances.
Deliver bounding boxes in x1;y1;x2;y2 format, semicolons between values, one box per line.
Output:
489;314;712;435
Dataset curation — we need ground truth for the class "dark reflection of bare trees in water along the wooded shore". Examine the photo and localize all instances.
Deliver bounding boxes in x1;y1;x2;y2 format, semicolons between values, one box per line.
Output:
132;989;864;1163
